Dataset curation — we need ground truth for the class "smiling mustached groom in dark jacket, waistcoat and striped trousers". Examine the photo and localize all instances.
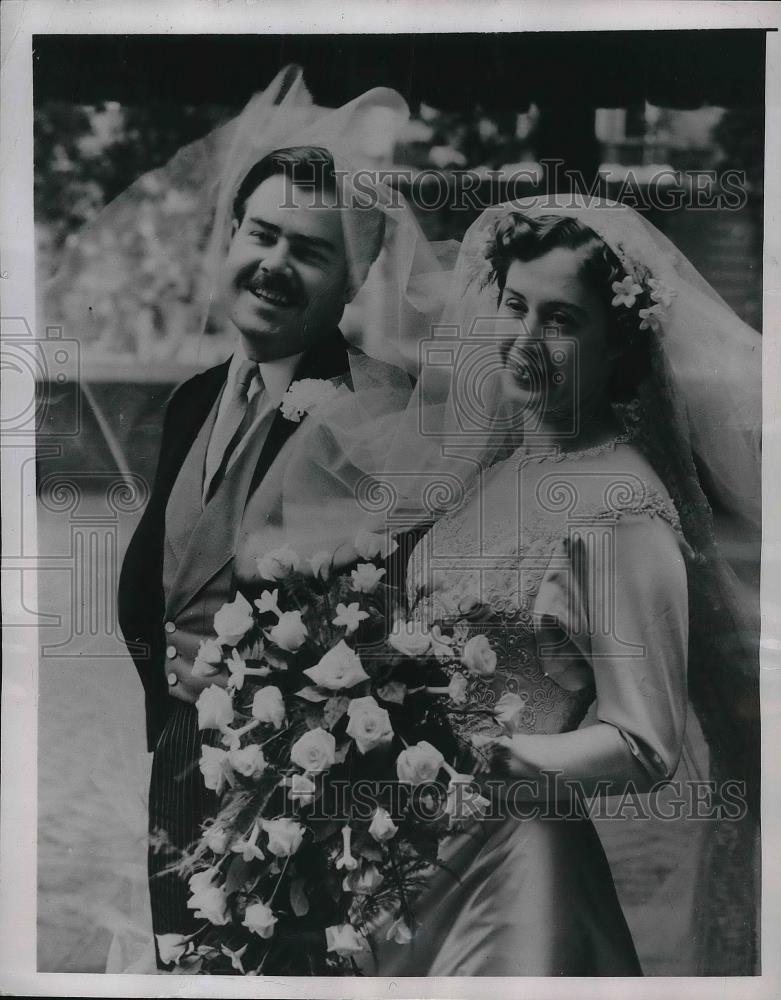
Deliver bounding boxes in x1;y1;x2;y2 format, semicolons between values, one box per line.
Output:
119;147;384;952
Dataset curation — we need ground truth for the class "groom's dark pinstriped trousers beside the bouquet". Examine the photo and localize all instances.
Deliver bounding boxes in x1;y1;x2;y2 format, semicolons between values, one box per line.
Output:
148;701;220;965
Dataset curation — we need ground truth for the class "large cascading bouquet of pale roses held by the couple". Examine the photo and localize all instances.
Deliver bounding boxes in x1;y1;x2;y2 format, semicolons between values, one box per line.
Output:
158;532;495;975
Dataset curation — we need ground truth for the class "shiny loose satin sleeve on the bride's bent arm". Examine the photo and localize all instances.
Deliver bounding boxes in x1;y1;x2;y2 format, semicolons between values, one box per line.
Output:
534;515;689;781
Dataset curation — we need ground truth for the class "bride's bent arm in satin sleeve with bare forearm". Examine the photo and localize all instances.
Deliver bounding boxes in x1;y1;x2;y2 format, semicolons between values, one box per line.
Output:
495;516;688;795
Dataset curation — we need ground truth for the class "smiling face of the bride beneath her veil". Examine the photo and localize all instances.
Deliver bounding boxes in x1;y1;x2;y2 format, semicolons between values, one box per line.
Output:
499;248;611;430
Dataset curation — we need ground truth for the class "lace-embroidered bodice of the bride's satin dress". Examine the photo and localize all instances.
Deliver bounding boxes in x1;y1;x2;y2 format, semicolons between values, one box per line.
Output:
407;444;680;737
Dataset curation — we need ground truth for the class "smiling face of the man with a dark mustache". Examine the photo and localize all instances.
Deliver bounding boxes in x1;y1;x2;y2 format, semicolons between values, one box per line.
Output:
222;174;348;361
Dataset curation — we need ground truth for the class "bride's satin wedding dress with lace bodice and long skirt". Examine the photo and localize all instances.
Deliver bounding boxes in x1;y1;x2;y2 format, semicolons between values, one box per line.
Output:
360;439;688;976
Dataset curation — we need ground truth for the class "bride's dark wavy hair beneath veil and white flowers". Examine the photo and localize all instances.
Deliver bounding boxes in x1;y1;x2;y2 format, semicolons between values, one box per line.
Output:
485;212;651;403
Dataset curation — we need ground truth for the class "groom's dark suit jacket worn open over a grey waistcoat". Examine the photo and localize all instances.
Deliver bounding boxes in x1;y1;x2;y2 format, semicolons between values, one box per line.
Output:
118;330;349;750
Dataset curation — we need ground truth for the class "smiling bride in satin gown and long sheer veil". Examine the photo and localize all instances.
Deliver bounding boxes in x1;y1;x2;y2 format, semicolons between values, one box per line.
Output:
308;203;759;977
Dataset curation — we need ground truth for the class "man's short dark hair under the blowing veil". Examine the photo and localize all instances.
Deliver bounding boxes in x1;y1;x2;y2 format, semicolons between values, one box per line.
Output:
233;146;385;291
